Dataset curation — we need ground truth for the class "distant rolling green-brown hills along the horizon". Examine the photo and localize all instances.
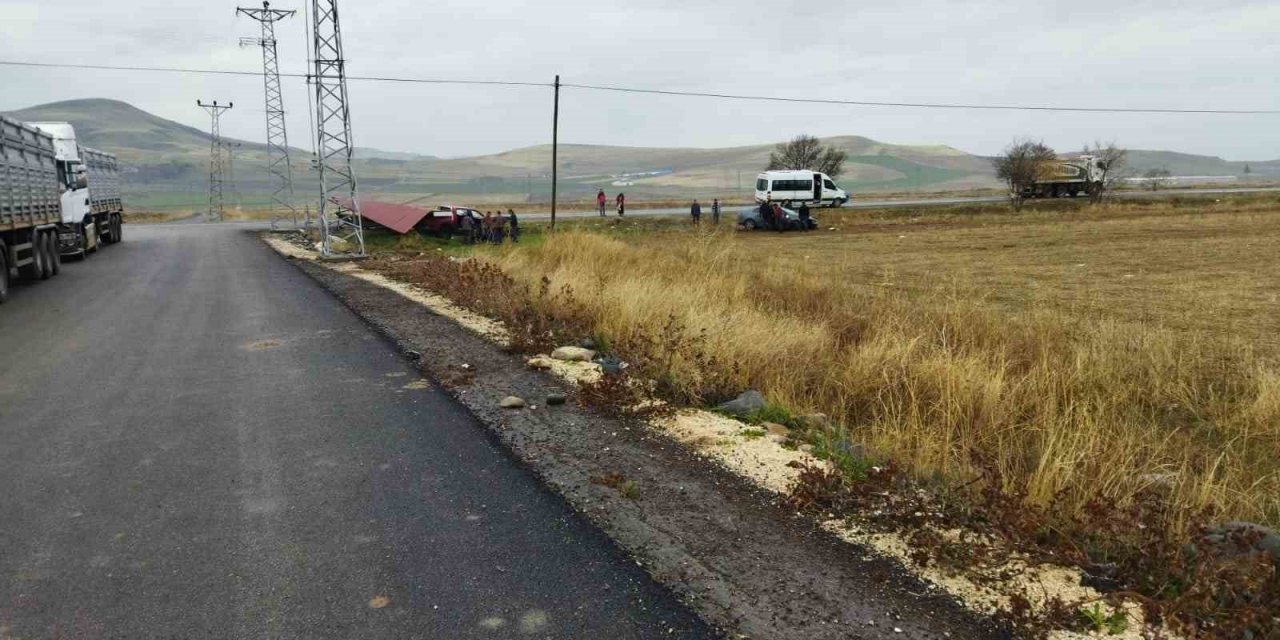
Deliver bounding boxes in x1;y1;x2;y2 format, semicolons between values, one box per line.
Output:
6;99;1280;209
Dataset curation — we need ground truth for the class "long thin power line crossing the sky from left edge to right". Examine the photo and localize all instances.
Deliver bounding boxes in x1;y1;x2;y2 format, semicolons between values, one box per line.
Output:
0;60;1280;115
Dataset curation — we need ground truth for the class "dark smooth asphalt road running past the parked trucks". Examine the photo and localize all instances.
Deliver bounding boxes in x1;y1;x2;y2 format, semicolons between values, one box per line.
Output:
0;225;712;640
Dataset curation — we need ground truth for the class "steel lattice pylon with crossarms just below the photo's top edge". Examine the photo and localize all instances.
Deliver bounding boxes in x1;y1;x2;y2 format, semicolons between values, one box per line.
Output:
236;0;300;229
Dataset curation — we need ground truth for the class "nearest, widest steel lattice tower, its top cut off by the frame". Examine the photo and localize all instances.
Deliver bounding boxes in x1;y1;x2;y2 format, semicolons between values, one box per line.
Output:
311;0;365;257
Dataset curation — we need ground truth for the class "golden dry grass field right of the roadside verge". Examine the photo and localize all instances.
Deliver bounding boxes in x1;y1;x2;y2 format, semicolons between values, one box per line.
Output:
485;196;1280;530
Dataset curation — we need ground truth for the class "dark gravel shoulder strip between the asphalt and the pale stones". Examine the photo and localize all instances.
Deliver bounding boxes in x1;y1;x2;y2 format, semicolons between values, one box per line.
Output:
270;235;1009;640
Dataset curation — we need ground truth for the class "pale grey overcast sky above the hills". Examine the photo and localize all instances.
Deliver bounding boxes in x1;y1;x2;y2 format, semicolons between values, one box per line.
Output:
0;0;1280;160
